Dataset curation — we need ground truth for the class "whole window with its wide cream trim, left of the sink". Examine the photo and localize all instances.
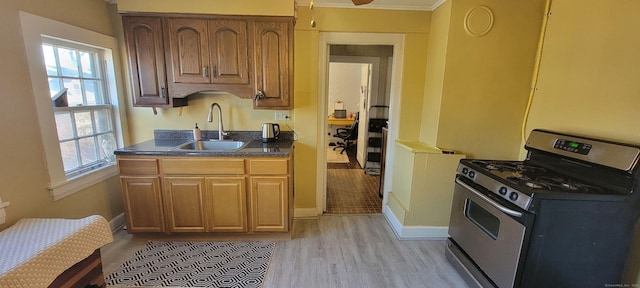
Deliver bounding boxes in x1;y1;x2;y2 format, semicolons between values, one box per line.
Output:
20;11;124;200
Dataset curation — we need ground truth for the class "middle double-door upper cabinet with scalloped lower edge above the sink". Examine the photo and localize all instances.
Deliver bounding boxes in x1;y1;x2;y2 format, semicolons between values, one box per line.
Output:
166;18;252;98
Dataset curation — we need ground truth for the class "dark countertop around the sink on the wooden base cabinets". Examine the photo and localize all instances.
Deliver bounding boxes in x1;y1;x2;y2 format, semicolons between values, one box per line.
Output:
114;131;293;157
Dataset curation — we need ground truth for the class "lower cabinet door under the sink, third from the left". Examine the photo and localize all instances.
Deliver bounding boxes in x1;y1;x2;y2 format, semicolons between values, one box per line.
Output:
205;177;247;232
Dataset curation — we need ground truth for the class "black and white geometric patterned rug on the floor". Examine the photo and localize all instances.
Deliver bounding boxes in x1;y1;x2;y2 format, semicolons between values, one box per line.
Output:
105;241;275;287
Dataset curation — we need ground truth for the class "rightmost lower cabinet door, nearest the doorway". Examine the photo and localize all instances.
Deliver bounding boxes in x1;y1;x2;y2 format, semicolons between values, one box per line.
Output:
250;176;289;232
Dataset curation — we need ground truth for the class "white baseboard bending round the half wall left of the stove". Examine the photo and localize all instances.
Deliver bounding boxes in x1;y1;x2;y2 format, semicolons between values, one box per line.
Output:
382;205;449;240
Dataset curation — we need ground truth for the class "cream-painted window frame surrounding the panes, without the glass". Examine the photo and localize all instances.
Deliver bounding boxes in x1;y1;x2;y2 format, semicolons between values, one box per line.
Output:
19;11;126;200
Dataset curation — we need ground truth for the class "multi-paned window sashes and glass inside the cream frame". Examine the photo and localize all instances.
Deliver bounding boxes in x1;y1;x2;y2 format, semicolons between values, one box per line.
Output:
42;37;116;178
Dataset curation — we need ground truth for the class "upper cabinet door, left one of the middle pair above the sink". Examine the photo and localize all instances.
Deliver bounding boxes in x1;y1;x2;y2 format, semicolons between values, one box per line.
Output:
167;18;211;83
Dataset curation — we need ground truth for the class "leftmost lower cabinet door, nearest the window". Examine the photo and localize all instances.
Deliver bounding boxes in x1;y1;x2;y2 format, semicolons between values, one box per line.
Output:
120;177;165;233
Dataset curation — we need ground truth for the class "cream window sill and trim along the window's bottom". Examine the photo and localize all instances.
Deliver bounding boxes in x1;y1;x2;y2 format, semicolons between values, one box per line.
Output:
49;164;118;201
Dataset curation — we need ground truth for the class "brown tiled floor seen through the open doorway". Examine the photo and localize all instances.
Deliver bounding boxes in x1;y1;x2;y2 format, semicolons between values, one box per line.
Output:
326;147;382;214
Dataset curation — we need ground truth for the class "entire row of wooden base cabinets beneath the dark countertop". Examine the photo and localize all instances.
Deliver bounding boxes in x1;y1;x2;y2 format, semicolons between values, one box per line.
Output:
118;156;293;233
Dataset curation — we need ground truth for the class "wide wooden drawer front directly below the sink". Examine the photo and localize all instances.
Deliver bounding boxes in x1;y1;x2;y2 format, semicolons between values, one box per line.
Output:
160;158;244;175
